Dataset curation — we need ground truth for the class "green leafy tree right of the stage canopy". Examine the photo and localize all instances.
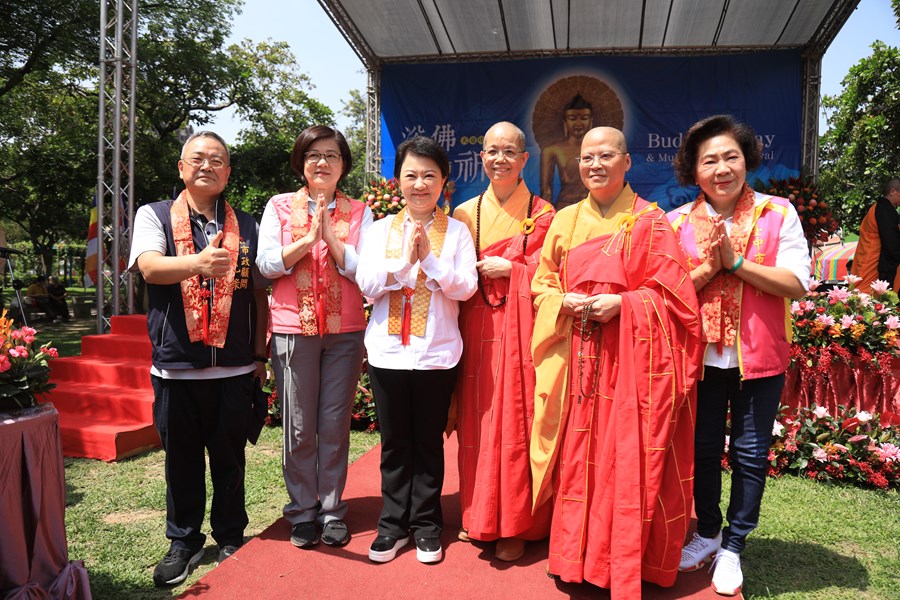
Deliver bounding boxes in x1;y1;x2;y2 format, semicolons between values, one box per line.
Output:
819;42;900;232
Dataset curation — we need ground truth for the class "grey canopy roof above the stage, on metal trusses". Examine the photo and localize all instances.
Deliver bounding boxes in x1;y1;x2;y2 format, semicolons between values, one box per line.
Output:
319;0;859;69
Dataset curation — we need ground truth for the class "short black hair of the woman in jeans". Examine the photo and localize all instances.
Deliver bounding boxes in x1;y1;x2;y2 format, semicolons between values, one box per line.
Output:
672;115;762;185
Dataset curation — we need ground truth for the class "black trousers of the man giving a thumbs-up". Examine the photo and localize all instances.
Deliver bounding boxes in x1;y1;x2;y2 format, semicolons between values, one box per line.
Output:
150;373;256;551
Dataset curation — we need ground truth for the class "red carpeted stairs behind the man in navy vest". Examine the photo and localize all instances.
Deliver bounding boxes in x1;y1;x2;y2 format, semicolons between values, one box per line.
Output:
49;315;160;460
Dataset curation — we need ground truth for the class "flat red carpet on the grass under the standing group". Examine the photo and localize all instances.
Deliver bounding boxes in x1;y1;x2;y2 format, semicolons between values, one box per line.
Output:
179;435;741;600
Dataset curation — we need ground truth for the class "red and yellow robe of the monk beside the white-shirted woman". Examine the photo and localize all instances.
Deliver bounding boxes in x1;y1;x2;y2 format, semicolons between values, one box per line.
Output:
453;182;554;541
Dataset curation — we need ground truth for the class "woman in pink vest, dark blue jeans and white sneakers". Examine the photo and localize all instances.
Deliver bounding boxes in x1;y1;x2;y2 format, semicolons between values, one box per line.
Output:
669;115;810;596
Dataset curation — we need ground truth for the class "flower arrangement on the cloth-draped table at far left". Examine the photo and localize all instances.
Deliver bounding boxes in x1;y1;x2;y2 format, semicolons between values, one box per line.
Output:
0;310;59;410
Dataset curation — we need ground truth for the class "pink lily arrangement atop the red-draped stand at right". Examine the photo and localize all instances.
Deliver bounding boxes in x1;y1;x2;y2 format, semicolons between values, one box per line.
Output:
791;275;900;370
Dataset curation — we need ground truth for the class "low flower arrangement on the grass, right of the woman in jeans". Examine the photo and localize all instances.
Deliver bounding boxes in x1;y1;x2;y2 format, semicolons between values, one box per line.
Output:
722;404;900;490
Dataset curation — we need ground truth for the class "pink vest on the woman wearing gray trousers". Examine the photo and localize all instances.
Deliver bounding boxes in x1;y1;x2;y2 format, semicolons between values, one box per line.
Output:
269;193;366;334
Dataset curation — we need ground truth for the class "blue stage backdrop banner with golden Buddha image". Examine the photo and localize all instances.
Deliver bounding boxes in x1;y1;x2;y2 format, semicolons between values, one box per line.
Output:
381;50;802;210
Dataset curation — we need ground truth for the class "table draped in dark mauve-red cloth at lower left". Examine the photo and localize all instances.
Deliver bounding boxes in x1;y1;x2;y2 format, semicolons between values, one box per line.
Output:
0;404;91;600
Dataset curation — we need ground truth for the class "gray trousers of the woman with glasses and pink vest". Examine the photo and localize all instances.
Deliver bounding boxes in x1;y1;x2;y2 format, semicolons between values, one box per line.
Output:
272;331;365;525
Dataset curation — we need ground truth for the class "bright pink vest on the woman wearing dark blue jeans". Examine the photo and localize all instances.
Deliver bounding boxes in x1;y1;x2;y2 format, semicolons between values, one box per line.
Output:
668;193;792;379
